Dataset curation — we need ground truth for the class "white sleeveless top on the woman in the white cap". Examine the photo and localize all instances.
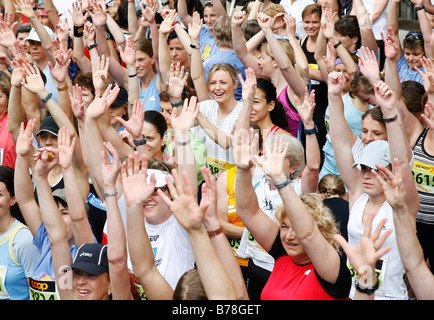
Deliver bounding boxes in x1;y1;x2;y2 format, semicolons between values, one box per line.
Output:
348;193;408;300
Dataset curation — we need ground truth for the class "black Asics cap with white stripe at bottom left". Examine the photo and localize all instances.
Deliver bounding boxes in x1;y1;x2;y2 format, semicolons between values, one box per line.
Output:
70;243;109;276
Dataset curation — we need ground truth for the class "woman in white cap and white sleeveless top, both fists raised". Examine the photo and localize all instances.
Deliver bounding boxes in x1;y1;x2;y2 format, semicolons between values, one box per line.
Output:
328;72;420;299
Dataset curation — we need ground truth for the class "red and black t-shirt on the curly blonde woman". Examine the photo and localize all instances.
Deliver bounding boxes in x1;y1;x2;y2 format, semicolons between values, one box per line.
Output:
261;236;351;300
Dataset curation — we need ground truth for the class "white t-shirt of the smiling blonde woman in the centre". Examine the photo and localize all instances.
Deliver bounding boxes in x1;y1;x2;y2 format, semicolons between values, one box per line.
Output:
191;100;243;174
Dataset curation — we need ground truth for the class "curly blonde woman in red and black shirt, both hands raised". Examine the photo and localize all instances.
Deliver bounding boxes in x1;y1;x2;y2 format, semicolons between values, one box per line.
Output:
232;132;351;300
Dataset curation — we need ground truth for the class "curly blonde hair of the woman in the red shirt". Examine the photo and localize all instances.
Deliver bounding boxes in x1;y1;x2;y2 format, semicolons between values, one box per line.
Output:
276;193;340;252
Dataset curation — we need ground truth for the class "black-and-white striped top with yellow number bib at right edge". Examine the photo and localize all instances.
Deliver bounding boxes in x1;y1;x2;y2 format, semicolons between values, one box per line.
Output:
412;127;434;224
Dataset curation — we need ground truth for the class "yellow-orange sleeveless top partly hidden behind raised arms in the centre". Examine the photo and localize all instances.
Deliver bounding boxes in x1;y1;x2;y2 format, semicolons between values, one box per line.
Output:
226;167;249;267
